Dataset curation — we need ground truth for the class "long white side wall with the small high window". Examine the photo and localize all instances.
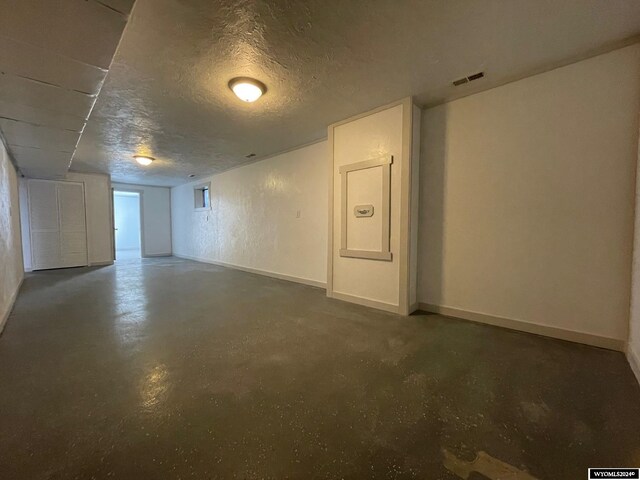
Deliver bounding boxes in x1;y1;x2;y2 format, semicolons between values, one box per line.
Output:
171;142;328;284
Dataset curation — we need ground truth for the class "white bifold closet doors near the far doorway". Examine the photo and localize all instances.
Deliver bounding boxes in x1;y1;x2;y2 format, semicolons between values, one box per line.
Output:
29;180;87;270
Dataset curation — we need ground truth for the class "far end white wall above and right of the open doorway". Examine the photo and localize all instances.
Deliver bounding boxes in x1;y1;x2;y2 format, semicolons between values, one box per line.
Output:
113;183;172;257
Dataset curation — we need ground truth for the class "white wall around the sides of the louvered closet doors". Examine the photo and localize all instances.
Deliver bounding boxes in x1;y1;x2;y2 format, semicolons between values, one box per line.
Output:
20;172;113;270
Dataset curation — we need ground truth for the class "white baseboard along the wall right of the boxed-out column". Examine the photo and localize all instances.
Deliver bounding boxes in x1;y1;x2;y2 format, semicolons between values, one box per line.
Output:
420;303;626;352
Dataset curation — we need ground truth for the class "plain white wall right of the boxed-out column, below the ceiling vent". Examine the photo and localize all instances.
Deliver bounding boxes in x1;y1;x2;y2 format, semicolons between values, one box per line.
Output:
419;45;640;345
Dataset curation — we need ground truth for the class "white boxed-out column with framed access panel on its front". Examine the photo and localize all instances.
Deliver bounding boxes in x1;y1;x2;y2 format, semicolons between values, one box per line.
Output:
327;98;420;315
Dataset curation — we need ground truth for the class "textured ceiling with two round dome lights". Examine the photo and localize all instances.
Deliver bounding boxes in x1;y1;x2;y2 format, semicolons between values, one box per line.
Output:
21;0;640;185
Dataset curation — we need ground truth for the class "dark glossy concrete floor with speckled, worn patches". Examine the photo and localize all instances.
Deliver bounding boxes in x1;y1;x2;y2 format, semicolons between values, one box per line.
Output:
0;258;640;480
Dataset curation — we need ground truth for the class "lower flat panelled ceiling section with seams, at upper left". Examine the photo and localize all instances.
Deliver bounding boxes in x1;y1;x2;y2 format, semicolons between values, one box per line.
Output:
0;0;133;178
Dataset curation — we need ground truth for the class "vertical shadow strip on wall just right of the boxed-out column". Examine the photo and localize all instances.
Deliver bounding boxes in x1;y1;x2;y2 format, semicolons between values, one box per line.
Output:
418;104;449;305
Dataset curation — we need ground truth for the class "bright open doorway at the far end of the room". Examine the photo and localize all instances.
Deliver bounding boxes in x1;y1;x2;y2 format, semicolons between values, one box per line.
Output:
113;190;142;261
